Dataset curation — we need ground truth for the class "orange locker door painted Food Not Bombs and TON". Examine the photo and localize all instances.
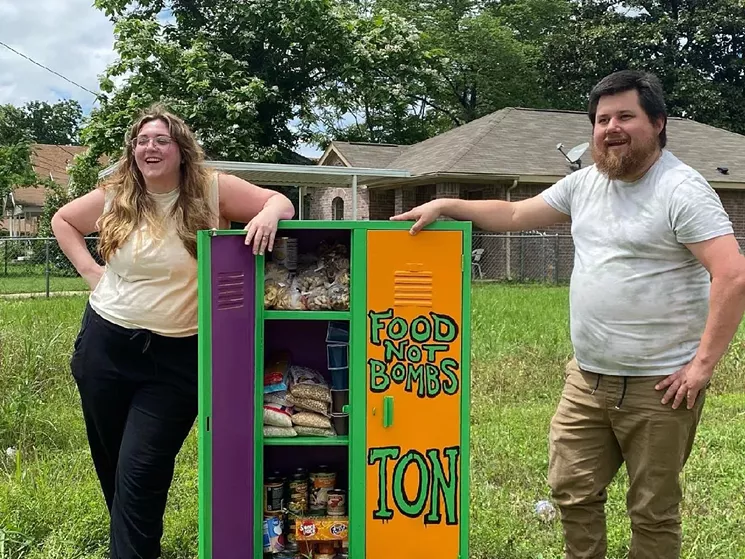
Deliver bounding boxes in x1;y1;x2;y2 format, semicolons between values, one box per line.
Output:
365;231;468;559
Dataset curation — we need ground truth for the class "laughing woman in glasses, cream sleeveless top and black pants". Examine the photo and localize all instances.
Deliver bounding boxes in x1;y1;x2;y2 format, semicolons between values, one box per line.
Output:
52;106;294;559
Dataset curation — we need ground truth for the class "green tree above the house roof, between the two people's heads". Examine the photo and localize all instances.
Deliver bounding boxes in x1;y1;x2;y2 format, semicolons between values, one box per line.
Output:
314;0;566;144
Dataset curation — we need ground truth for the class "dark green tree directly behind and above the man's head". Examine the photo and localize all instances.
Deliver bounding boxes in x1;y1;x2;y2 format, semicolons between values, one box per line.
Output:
543;0;745;133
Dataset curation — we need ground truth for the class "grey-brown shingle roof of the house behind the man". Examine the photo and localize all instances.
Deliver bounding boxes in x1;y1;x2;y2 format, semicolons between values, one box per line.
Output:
324;108;745;188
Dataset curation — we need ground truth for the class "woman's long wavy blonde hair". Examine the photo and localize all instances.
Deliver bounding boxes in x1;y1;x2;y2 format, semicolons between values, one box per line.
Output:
98;105;216;262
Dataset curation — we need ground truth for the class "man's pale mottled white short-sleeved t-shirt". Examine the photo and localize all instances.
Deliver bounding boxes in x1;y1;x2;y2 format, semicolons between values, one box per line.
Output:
542;150;733;376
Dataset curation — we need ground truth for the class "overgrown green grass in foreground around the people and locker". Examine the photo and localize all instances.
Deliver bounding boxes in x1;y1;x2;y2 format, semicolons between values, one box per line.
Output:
0;286;745;559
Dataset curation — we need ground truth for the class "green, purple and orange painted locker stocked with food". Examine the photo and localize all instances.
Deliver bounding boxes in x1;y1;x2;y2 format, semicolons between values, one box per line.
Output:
198;221;471;559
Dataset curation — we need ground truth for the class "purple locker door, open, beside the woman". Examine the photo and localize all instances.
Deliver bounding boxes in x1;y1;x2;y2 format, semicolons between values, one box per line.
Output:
211;235;256;559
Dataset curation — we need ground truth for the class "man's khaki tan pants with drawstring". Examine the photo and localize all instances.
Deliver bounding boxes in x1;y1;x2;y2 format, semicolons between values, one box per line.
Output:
548;359;705;559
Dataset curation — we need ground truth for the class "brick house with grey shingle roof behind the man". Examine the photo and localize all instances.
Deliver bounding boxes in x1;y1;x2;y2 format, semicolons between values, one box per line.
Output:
305;108;745;278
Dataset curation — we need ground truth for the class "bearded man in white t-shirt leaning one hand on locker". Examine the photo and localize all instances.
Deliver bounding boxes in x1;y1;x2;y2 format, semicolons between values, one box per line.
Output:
392;71;745;559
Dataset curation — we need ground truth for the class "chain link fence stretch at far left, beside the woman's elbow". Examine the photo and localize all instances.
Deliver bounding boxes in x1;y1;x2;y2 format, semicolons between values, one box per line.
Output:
0;237;101;297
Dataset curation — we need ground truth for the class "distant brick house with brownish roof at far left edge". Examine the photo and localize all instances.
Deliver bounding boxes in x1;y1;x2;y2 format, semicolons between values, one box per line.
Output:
0;144;88;236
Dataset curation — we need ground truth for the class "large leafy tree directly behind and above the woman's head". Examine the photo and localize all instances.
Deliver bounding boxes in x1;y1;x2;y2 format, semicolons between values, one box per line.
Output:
83;0;424;162
